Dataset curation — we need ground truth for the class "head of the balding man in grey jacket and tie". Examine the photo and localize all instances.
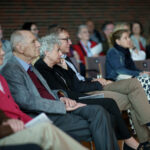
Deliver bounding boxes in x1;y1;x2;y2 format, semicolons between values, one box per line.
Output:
10;30;40;62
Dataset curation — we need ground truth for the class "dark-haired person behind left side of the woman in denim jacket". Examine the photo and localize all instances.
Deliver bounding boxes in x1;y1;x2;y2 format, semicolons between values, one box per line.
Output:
101;21;114;55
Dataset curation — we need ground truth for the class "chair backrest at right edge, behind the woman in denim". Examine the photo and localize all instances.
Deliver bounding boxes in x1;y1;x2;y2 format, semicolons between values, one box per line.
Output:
134;59;150;71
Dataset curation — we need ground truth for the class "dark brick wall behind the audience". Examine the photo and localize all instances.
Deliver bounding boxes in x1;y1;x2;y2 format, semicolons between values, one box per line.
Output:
0;0;150;42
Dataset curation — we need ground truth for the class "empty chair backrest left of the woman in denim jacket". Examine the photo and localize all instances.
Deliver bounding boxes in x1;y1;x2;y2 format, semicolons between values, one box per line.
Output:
85;56;106;78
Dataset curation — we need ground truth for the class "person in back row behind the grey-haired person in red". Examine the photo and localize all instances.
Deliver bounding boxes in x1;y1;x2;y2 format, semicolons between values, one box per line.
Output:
86;19;102;43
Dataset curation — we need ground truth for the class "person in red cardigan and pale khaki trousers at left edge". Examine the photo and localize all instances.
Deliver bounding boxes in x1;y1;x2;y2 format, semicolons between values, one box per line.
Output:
0;42;87;150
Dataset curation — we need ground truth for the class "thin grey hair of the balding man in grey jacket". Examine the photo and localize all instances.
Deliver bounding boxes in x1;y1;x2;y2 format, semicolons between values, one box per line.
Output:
10;30;24;50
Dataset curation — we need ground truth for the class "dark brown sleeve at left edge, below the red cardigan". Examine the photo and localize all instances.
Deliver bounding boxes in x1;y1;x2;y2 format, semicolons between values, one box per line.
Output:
0;110;13;138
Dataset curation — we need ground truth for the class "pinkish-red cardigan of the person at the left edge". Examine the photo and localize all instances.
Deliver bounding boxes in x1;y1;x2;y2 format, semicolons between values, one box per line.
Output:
0;75;32;123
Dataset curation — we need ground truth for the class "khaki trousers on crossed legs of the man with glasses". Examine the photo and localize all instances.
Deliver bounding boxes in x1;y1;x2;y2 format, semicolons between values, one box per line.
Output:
86;78;150;142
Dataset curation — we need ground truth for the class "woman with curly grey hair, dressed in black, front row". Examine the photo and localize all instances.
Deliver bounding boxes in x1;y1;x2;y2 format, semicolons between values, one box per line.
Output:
35;34;150;149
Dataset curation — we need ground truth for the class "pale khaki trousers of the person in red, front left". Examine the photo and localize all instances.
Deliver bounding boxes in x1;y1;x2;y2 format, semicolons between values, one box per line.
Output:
0;123;87;150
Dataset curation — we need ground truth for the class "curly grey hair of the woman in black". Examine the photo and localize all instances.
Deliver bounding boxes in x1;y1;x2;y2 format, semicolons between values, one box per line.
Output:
40;33;60;56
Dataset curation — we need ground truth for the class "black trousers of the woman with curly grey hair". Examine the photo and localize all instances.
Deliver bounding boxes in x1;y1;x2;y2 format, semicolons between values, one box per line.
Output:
77;98;131;139
